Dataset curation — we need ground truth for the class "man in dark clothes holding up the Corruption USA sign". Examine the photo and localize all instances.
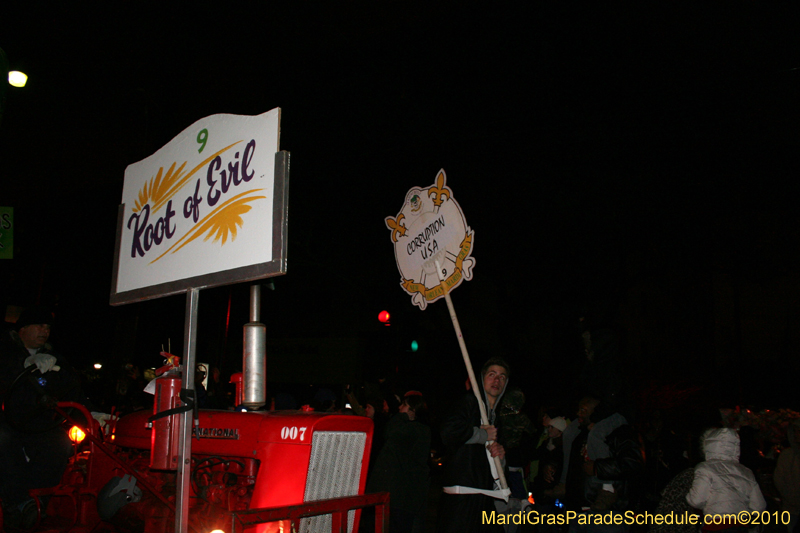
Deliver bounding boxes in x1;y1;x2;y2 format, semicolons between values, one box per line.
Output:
437;358;510;533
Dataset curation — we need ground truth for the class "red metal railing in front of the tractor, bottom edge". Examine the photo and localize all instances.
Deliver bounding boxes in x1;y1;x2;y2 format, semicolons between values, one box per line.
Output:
231;492;389;533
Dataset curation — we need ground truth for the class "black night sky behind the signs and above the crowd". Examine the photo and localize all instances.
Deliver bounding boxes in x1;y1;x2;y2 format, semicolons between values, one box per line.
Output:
0;1;800;408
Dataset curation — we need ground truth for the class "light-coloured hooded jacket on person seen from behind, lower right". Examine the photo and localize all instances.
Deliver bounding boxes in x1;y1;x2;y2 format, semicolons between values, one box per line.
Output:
686;428;767;515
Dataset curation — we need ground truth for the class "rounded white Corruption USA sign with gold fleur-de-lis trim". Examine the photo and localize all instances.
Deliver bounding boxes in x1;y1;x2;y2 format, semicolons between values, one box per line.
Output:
385;169;475;310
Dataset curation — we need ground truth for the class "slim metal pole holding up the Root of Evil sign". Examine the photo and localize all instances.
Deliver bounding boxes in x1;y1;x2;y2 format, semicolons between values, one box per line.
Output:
175;289;200;533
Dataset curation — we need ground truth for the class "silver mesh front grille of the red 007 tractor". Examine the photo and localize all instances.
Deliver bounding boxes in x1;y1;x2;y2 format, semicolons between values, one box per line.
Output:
300;431;367;533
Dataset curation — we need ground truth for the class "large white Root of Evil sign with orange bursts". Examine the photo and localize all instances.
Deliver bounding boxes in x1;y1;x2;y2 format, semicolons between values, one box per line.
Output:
111;109;288;304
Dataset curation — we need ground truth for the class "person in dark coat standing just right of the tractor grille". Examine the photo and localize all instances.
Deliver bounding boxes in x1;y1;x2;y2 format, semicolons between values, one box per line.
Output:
367;391;431;533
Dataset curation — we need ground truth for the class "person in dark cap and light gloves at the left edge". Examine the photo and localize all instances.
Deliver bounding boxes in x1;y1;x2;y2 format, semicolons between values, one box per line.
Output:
0;308;83;529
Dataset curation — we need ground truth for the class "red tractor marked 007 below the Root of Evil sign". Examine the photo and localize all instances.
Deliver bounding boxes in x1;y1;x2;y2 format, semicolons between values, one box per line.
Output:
3;356;388;533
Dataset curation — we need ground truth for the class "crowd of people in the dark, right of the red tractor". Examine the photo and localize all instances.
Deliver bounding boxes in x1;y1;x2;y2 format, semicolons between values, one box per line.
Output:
332;314;800;533
